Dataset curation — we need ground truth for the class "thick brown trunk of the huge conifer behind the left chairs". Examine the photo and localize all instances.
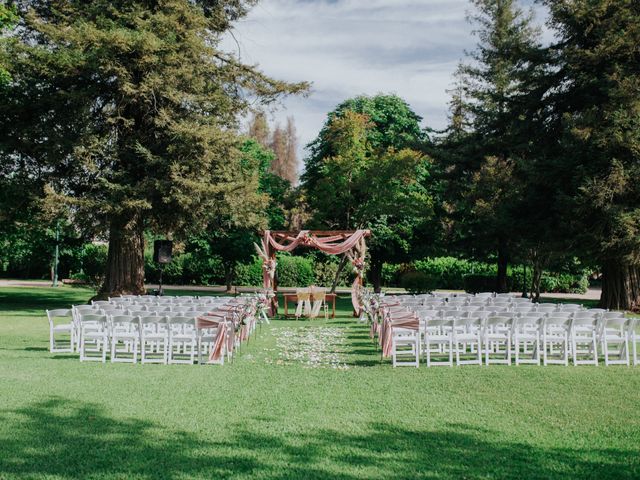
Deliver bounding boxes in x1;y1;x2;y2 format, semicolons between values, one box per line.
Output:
100;215;145;296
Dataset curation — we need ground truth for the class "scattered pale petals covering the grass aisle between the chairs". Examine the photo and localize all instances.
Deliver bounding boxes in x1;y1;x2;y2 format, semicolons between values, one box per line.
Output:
266;327;349;370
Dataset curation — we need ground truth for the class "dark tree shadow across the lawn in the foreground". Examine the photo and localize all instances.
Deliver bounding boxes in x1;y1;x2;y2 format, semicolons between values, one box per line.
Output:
0;399;640;480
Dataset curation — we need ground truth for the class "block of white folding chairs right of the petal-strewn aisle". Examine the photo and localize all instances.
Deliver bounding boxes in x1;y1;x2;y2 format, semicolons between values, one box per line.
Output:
391;311;640;367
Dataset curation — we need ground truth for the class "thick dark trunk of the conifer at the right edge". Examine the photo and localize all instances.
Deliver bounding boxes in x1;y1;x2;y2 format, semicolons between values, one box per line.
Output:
600;259;640;310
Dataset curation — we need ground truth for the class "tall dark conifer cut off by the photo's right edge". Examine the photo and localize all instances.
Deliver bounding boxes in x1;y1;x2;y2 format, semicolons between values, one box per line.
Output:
539;0;640;309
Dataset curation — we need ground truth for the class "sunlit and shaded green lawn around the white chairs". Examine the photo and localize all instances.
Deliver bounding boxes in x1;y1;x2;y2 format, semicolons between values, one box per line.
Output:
0;287;640;480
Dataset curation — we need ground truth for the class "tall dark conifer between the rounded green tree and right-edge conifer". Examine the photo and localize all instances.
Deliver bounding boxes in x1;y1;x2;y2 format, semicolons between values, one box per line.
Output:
440;0;537;291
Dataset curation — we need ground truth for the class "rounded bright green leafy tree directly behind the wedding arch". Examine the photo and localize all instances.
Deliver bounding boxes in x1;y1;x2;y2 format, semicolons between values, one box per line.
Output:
302;95;433;289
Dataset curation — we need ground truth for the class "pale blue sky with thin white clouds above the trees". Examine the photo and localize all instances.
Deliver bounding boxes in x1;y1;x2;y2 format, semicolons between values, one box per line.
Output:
223;0;548;158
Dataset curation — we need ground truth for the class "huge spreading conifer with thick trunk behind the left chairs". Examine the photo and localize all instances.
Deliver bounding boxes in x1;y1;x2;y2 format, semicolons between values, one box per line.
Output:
0;0;307;295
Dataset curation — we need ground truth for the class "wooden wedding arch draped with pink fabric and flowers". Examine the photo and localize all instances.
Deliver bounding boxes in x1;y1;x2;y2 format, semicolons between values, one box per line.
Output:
256;230;371;315
